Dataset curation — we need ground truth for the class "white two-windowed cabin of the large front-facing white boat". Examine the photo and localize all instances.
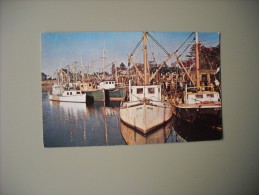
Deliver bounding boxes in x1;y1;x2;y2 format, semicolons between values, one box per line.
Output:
129;85;162;101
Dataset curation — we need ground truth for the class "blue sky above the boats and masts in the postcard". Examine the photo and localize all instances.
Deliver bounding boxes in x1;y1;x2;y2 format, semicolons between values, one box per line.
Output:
41;32;219;75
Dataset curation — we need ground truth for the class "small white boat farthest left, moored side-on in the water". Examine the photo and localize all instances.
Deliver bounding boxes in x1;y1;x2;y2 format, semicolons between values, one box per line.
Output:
49;83;86;103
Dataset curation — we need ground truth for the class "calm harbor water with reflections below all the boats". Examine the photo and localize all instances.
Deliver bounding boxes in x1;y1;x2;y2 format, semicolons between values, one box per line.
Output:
42;92;222;147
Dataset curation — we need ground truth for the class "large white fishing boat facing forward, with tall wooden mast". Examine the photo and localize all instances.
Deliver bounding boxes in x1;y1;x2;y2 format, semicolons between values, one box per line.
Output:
120;32;172;134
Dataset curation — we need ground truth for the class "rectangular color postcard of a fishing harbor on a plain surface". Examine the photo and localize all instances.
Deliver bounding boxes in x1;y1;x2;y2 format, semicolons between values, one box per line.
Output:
41;32;223;148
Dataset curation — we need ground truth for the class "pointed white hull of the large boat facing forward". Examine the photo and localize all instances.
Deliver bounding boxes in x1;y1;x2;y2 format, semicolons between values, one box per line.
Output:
120;101;172;133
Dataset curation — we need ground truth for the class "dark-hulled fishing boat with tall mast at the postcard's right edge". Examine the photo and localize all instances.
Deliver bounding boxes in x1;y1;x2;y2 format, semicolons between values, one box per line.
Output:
174;32;221;122
